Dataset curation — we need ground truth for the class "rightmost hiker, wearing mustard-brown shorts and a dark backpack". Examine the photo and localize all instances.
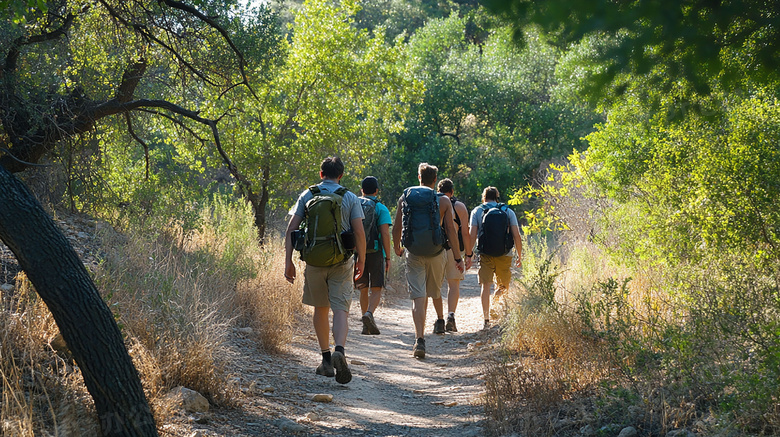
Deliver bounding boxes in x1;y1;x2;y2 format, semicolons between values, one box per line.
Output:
469;187;523;328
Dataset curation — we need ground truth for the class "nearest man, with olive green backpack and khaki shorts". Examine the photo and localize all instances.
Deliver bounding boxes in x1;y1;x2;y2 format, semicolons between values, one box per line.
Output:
284;156;366;384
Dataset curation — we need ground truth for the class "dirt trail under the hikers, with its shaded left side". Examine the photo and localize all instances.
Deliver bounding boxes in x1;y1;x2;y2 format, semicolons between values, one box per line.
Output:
198;269;493;436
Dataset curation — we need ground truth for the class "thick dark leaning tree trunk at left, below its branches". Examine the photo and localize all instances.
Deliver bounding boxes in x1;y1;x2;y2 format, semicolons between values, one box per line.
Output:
0;165;158;437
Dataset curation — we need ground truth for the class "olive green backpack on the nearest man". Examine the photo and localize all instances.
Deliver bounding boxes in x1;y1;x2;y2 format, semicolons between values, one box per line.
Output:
300;185;352;267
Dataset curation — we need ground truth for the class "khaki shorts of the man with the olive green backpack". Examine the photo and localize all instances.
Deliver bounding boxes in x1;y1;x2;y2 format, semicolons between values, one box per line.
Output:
303;258;355;311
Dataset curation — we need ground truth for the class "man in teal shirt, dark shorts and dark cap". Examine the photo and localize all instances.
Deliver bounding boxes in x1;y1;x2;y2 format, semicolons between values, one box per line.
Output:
355;176;392;335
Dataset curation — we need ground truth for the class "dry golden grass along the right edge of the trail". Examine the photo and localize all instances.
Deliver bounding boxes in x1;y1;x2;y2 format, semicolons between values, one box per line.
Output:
484;242;691;435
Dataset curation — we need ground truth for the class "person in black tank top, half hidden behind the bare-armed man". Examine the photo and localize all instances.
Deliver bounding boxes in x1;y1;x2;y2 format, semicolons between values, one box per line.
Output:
433;178;474;334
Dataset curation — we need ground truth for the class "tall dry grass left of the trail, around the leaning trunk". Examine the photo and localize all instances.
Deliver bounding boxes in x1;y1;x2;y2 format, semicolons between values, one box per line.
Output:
0;199;301;436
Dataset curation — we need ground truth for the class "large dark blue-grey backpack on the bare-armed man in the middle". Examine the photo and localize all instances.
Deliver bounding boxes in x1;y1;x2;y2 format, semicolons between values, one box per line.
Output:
401;186;444;257
